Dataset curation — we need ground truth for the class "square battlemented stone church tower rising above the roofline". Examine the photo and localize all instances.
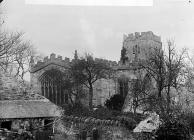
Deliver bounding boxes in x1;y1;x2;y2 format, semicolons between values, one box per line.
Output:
121;31;162;65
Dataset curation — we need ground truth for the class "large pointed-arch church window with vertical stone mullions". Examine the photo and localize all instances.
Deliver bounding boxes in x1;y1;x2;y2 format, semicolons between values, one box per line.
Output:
38;68;68;105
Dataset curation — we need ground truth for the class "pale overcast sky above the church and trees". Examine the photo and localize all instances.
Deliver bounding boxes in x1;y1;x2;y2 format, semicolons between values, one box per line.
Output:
1;0;194;61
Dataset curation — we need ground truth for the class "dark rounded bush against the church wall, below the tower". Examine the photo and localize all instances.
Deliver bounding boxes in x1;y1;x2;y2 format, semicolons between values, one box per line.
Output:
105;94;124;111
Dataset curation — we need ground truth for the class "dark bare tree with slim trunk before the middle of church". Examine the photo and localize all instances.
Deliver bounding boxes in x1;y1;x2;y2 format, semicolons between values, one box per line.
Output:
70;54;110;109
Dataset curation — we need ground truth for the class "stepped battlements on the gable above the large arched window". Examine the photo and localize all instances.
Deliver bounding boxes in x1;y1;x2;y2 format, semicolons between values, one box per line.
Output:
30;53;70;73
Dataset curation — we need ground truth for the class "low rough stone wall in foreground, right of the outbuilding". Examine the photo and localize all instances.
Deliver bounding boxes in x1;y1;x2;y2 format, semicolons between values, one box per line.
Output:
54;116;133;140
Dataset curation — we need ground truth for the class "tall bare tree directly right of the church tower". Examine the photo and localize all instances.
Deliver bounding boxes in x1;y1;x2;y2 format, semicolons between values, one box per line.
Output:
141;40;185;113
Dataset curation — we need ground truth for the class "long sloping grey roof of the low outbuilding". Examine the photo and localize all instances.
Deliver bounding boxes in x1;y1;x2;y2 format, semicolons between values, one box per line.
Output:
0;99;60;119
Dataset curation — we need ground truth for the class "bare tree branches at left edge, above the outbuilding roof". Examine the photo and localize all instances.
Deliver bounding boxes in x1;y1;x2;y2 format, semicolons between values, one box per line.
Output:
0;32;36;81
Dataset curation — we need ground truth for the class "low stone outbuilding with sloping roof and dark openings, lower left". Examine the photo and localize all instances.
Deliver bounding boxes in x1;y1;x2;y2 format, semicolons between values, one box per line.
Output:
0;99;61;132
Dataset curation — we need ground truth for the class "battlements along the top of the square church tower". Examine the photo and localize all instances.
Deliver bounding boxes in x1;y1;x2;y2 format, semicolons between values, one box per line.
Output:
123;31;161;42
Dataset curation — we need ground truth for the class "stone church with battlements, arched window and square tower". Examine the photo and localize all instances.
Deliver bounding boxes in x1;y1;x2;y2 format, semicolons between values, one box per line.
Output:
30;31;162;106
